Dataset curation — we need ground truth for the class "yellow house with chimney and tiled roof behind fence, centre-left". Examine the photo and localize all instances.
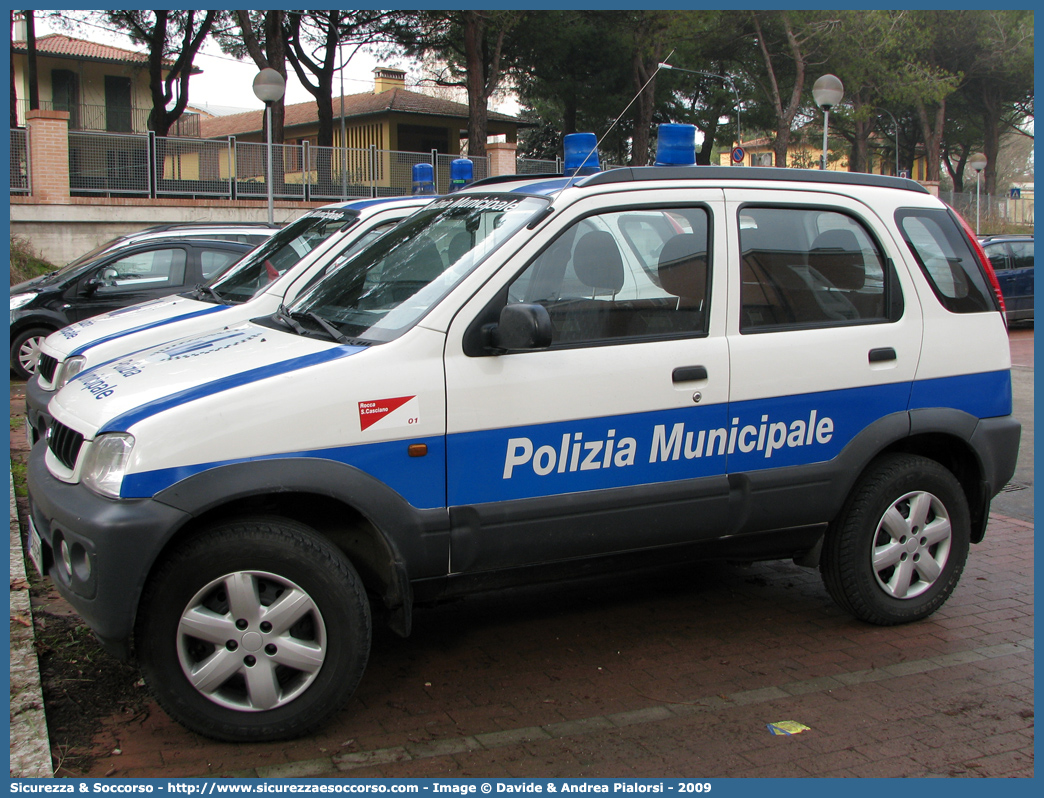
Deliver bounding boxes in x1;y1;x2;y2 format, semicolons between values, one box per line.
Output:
200;68;525;155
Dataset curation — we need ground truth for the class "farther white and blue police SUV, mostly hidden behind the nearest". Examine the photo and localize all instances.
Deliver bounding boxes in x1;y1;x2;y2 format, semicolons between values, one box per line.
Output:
25;196;433;443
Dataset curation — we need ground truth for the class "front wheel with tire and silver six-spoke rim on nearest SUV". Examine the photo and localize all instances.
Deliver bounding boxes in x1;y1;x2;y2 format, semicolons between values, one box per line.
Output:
135;518;371;742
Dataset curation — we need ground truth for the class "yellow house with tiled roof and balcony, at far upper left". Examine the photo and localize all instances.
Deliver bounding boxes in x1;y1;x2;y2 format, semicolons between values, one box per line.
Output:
10;20;200;135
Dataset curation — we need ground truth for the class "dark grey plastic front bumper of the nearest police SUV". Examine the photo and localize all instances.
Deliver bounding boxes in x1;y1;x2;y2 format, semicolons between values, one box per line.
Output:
28;443;190;654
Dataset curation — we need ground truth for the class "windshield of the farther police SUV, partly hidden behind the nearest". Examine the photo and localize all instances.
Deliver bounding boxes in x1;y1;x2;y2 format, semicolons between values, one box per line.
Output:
200;208;359;304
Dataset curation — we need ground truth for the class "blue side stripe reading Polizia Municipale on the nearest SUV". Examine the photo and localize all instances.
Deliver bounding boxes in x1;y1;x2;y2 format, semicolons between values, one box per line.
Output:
116;371;1011;509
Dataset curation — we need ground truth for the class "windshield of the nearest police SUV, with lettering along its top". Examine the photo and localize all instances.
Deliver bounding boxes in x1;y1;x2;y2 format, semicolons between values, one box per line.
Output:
289;194;548;342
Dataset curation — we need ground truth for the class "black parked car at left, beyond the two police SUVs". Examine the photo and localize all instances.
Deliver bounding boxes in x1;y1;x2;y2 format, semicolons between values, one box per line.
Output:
10;235;261;379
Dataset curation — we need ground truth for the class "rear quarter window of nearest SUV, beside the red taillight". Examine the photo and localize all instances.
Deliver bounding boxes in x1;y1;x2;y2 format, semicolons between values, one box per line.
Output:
896;208;997;313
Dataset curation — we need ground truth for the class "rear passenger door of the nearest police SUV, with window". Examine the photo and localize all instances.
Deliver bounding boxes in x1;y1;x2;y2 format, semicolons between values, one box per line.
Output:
726;189;922;532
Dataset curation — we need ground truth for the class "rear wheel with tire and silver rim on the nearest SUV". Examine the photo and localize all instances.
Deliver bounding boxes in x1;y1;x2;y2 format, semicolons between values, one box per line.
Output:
820;454;971;626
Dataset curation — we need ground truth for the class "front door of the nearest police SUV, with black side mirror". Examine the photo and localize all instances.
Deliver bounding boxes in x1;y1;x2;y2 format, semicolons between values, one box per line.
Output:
446;189;730;572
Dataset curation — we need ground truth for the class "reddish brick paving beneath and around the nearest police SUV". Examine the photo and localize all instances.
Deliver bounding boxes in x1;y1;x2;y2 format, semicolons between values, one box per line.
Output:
75;516;1034;777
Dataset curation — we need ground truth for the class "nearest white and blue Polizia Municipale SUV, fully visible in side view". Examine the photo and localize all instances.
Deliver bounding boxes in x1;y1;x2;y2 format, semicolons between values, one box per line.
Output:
29;132;1020;740
